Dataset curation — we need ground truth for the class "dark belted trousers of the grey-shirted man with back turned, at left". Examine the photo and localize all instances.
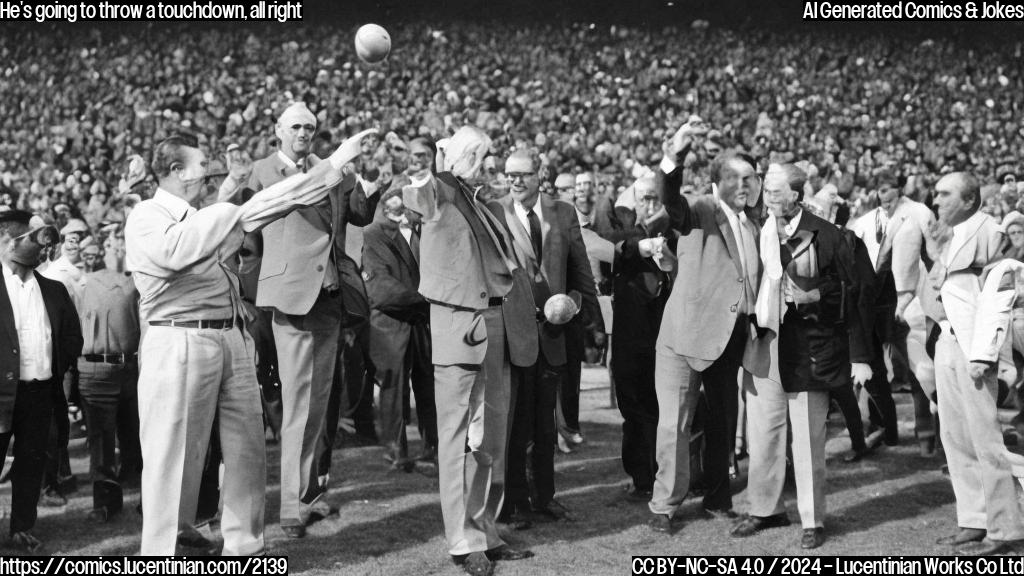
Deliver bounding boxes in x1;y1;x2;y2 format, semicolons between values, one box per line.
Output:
78;359;142;508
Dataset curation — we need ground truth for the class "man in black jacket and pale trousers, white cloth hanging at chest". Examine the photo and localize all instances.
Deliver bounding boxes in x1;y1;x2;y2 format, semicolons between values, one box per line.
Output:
732;164;871;548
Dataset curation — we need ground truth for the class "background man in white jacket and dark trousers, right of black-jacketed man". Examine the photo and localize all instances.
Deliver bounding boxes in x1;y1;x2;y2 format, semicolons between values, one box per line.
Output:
850;170;935;455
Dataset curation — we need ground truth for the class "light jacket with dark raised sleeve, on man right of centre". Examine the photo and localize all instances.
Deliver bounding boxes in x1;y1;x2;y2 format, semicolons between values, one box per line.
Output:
638;163;770;376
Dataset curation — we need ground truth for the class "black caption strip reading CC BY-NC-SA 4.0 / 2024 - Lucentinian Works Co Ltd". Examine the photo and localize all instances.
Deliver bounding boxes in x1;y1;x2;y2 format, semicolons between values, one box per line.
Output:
631;556;1024;576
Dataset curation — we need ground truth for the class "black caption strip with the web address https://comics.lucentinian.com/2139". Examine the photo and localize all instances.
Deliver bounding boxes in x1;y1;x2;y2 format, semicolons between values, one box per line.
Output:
0;556;288;576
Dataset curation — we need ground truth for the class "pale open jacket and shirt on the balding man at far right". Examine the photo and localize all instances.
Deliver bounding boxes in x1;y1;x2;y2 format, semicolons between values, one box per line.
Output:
921;212;1002;360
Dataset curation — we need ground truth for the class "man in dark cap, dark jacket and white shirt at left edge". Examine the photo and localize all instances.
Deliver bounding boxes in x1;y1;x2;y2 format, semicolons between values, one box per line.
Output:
0;210;82;551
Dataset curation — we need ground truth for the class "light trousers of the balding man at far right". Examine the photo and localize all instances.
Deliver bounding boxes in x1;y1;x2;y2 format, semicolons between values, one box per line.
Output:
935;332;1024;540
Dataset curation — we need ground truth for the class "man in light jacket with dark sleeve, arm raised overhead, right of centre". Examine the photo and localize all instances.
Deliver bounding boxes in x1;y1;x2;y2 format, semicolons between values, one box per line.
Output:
638;117;767;533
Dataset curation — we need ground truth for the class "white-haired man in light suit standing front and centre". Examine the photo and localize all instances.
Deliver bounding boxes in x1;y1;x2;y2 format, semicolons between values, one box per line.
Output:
402;126;538;575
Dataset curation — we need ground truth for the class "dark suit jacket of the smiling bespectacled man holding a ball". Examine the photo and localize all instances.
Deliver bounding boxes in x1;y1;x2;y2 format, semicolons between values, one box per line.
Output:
487;195;604;366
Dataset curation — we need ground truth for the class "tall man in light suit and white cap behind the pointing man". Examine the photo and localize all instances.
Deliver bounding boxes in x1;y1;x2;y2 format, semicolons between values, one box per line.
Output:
249;102;377;538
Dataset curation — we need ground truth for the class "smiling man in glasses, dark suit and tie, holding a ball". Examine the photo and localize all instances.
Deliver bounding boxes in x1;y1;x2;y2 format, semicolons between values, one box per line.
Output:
490;151;604;521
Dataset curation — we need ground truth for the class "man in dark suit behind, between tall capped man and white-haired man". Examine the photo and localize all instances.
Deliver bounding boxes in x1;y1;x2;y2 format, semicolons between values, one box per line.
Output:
362;180;437;471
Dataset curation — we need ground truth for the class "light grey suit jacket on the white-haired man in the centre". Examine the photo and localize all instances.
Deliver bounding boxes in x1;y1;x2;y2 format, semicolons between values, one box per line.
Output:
402;172;538;367
